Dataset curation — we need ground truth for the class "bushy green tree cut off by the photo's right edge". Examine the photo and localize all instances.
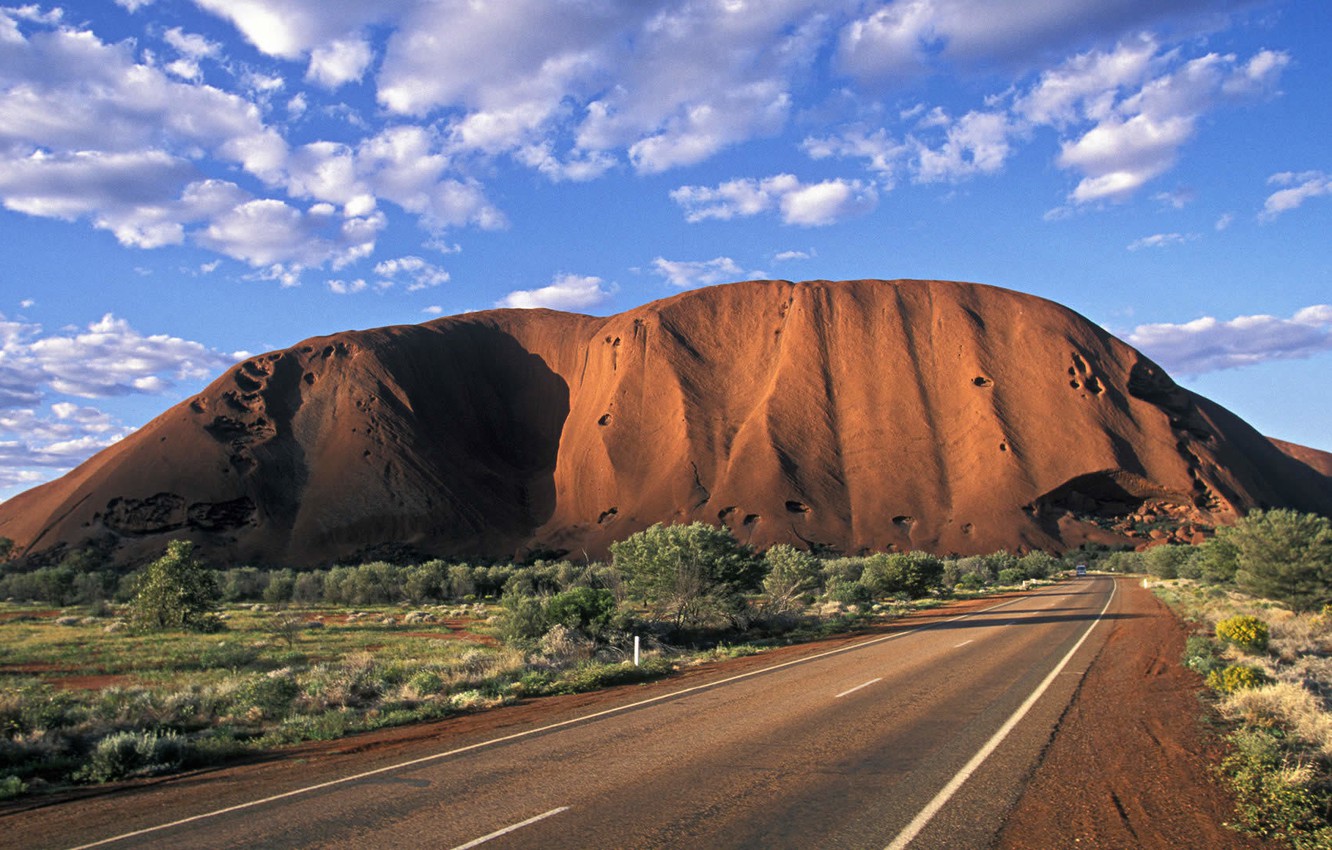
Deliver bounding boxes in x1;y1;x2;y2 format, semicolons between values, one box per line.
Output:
1217;508;1332;610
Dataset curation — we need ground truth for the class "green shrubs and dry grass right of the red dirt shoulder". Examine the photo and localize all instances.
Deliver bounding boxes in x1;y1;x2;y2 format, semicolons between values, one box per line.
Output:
1140;510;1332;850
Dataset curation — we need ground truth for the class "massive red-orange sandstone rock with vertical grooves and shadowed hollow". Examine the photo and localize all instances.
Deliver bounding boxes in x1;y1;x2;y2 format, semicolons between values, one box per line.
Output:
0;281;1332;565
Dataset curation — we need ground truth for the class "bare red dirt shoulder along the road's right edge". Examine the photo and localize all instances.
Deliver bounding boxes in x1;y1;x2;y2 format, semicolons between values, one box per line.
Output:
998;581;1280;850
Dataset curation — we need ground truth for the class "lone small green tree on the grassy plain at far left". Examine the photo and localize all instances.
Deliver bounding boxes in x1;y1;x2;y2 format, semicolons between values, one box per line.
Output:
129;540;220;632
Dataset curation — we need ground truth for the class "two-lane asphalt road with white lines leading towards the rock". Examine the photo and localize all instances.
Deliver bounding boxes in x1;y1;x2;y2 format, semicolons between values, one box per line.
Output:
10;577;1132;850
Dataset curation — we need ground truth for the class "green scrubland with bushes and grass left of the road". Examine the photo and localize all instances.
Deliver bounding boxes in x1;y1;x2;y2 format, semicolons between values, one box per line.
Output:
0;524;1064;798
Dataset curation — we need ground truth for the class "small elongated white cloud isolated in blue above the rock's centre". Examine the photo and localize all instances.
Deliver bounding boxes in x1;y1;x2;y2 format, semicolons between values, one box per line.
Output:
670;175;879;226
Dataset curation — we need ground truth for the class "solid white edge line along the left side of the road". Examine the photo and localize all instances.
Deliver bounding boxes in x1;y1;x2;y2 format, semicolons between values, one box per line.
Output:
62;593;1060;850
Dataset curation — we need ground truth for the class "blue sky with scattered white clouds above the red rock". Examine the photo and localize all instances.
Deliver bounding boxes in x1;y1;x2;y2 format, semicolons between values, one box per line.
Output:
0;0;1332;498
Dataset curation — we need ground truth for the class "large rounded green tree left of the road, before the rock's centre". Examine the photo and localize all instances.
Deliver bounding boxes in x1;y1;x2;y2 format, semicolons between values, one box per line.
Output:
610;522;763;629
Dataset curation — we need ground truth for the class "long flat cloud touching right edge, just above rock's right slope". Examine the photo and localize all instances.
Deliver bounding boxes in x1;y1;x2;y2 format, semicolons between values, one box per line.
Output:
1126;304;1332;374
